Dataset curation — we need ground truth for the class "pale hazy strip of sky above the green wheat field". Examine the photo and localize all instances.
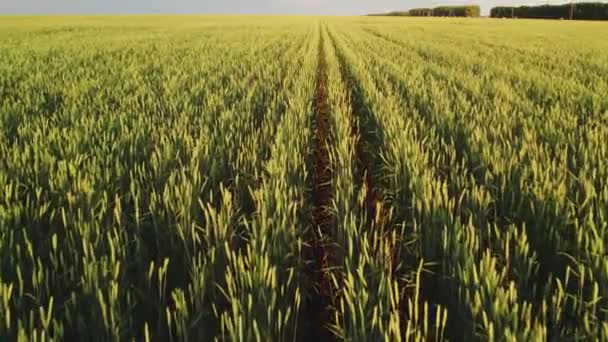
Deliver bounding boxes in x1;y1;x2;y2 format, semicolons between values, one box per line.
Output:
0;0;600;15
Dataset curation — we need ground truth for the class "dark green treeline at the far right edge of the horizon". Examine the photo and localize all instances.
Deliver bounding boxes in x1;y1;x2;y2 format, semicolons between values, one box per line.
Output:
490;2;608;20
